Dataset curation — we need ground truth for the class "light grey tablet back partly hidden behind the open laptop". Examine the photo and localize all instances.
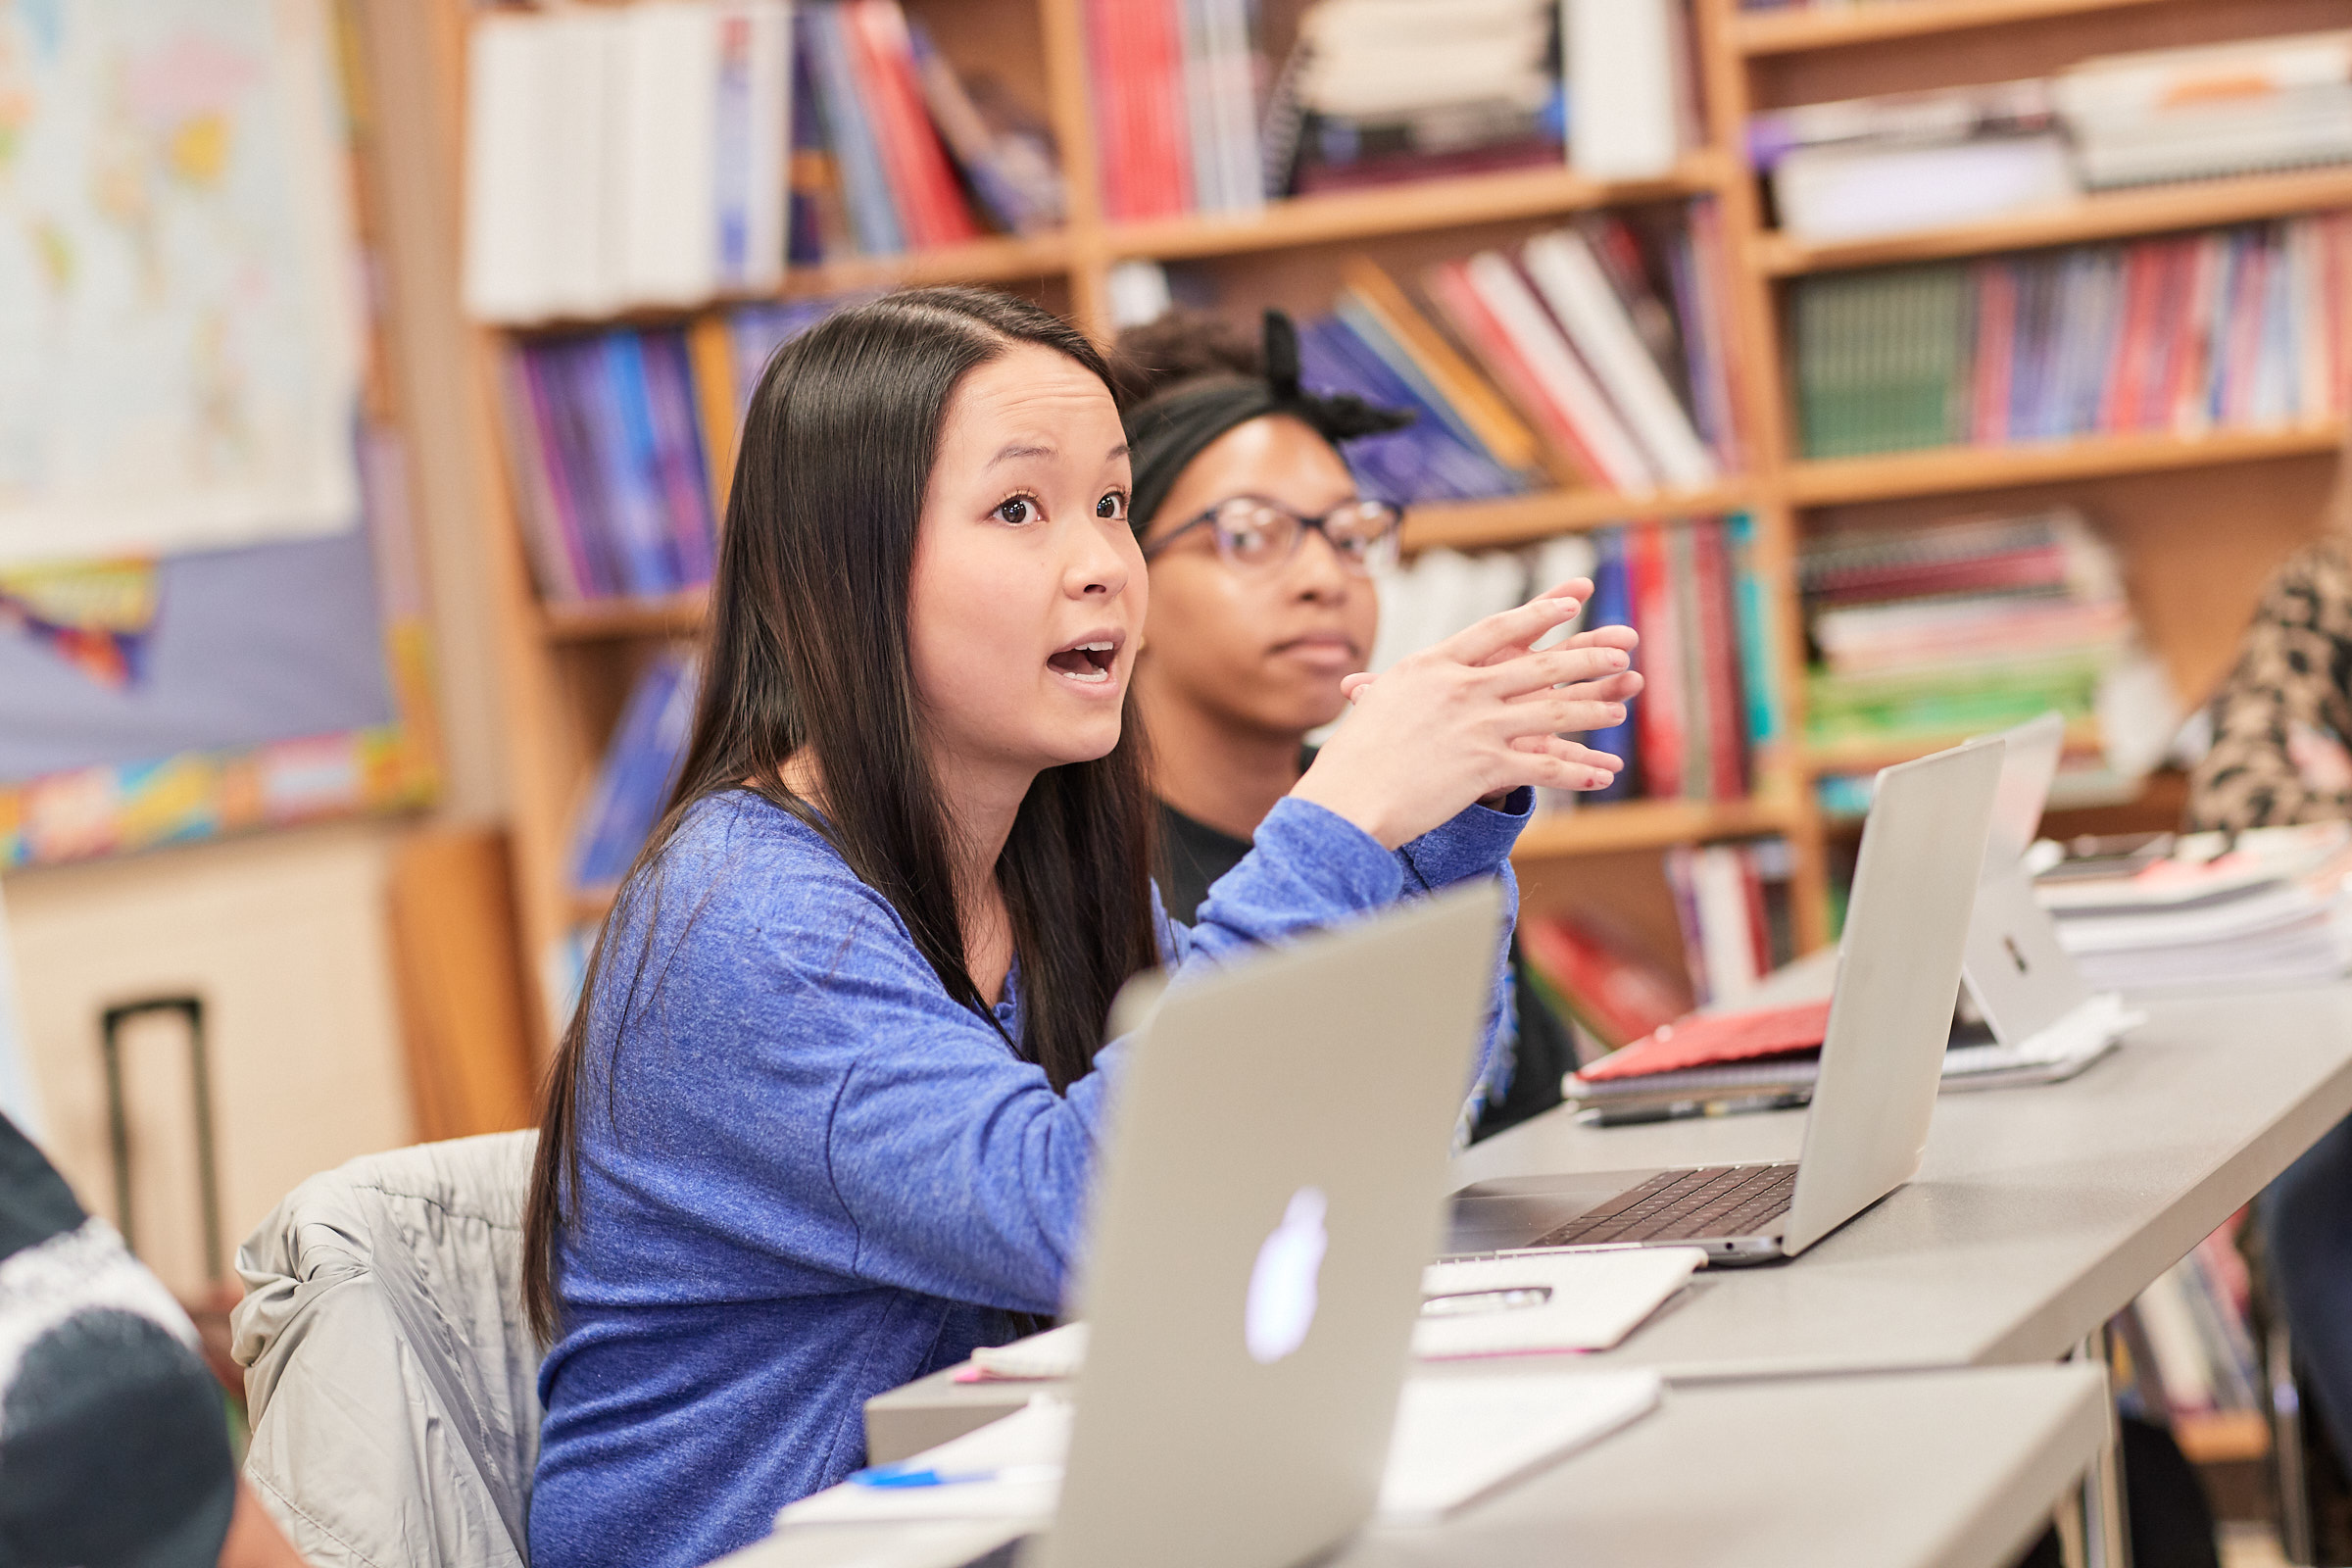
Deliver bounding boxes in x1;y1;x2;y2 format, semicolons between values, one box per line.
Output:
1959;712;2091;1046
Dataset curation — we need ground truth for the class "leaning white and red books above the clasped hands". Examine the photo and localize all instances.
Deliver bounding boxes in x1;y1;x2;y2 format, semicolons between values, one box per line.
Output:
1423;200;1739;494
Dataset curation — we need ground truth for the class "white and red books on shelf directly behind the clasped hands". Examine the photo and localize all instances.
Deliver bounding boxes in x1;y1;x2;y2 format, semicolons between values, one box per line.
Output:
1371;514;1778;808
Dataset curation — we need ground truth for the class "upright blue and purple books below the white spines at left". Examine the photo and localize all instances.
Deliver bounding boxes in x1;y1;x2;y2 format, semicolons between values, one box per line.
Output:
506;326;717;602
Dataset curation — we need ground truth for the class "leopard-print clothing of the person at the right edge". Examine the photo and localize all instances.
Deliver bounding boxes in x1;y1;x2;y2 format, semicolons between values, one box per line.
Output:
2189;541;2352;827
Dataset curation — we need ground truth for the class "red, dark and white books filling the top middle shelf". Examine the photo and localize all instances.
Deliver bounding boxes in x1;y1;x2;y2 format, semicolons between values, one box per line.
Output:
1087;0;1700;219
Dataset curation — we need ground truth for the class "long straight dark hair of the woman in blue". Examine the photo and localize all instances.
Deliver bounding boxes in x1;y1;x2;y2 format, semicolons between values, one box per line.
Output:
522;289;1157;1340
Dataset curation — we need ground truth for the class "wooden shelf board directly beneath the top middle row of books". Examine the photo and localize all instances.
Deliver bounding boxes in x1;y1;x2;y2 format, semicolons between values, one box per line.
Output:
1103;153;1731;261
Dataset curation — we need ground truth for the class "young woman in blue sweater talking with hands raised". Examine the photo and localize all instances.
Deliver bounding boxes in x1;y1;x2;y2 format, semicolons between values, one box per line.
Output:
524;289;1640;1568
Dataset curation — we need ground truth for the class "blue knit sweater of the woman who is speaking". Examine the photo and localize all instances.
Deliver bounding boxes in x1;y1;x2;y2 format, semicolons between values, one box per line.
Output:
531;792;1527;1568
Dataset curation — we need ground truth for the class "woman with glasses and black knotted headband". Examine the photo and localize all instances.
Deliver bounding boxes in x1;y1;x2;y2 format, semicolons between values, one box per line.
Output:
1119;315;1635;1138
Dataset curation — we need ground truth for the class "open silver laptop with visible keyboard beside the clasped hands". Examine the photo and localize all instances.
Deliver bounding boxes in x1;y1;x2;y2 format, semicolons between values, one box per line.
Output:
1448;738;2004;1262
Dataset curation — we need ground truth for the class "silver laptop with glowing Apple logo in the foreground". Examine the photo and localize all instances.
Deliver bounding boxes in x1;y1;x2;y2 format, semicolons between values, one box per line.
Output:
978;882;1503;1568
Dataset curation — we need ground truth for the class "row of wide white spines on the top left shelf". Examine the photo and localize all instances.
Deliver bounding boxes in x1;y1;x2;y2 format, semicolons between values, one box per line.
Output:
466;0;793;322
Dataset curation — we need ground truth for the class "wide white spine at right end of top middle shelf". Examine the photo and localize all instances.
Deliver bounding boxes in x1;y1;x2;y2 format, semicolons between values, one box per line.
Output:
1559;0;1682;178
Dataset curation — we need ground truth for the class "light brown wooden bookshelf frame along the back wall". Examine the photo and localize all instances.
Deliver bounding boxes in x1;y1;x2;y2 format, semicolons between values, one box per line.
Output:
444;0;2352;1053
